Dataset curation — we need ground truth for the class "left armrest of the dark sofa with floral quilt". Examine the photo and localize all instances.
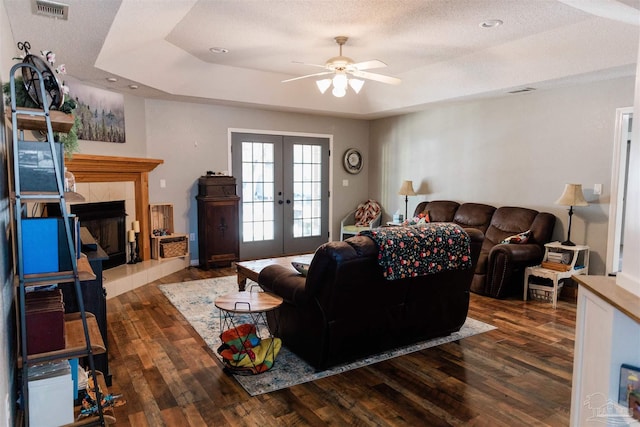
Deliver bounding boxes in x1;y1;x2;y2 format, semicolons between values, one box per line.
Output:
258;265;309;304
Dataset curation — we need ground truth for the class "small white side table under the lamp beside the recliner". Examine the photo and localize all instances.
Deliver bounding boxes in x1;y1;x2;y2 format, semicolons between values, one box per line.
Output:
524;242;590;308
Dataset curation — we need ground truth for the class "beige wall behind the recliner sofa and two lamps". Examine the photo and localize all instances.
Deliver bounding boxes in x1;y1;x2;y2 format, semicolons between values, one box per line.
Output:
369;78;634;274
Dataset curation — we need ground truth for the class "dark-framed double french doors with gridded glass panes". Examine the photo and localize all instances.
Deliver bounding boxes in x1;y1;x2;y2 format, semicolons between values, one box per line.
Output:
231;133;329;260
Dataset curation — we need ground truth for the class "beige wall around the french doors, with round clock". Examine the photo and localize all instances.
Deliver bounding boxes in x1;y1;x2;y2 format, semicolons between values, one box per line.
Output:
143;100;369;260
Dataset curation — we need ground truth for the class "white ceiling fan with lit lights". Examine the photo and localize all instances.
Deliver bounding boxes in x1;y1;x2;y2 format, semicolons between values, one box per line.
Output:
282;36;402;97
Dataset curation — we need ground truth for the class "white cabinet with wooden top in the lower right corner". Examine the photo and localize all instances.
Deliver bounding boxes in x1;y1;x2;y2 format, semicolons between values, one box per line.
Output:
571;276;640;427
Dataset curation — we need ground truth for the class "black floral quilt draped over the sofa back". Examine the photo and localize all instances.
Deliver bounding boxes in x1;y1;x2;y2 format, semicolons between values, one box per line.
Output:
360;222;472;280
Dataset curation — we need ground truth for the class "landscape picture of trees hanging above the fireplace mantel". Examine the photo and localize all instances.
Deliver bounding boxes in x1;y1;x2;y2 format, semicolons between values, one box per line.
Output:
66;81;126;143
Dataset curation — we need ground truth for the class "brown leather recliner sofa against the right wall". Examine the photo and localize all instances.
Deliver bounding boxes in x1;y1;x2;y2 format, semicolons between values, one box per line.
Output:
414;200;556;298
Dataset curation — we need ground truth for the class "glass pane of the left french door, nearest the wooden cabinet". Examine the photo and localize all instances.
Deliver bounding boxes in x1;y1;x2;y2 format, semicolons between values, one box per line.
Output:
242;142;275;242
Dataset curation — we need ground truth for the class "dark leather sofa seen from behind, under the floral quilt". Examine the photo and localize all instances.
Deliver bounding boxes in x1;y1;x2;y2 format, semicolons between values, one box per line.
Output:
258;229;483;369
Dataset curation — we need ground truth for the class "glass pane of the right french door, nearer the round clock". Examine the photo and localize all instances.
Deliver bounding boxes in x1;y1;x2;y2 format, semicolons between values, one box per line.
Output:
293;144;322;238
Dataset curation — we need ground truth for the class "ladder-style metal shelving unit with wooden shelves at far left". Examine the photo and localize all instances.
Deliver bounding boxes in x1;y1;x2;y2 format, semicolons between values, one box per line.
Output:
9;62;110;426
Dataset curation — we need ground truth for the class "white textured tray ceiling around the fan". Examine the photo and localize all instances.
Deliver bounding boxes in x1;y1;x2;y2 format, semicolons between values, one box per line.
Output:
4;0;640;118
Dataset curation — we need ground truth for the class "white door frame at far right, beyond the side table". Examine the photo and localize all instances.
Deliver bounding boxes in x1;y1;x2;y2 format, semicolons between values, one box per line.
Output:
606;107;637;274
